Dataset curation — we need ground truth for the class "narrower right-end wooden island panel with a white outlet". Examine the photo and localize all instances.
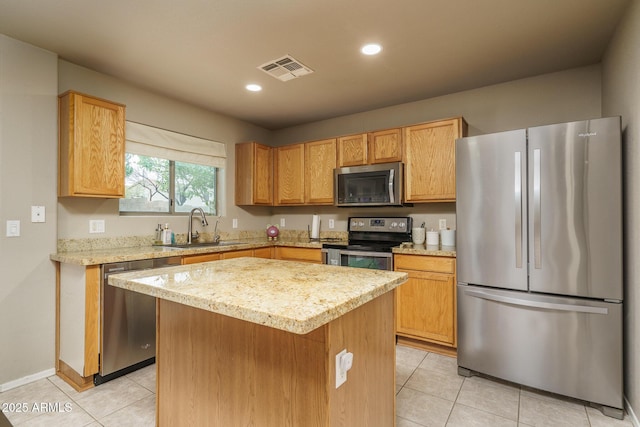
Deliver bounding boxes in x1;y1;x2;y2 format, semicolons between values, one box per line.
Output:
328;292;396;427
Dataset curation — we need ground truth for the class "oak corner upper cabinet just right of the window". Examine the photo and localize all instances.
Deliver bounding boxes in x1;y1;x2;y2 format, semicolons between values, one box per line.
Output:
235;142;273;206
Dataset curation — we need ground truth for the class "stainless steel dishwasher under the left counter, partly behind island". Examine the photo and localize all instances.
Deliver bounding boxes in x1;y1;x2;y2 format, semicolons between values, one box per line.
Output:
93;257;180;385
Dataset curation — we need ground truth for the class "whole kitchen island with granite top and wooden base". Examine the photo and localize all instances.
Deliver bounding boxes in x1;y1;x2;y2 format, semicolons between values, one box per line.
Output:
110;258;407;427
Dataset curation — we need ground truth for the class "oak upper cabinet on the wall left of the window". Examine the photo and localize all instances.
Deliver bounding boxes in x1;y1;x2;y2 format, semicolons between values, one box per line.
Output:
58;91;125;198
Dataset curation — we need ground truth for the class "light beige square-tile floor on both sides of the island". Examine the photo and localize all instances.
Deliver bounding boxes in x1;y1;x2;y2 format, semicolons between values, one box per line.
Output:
0;346;632;427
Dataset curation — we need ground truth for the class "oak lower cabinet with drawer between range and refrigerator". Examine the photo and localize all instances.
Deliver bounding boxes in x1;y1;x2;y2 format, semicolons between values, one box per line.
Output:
394;254;457;354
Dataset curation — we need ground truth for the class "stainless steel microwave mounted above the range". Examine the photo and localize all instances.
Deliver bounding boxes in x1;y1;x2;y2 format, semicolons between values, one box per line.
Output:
333;162;404;207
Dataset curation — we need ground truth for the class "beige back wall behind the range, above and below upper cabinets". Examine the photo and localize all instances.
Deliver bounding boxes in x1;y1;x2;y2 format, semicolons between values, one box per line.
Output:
272;65;601;236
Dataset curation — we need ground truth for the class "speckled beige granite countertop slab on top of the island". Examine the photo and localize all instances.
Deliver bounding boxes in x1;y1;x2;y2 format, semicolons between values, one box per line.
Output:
109;257;408;334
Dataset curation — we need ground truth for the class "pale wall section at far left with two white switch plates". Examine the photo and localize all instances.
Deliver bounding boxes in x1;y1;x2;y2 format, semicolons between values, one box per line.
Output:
0;35;58;391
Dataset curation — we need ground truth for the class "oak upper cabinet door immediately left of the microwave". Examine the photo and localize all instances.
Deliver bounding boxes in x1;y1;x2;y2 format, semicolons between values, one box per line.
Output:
304;139;336;205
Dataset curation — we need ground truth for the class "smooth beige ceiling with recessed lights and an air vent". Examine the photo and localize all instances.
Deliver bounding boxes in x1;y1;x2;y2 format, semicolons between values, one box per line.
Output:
0;0;630;129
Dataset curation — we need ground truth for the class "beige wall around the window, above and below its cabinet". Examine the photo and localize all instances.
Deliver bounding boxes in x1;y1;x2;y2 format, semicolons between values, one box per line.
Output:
58;60;270;239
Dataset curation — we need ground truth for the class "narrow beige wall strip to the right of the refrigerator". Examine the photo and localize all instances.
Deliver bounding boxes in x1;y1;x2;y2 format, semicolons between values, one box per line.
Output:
602;1;640;422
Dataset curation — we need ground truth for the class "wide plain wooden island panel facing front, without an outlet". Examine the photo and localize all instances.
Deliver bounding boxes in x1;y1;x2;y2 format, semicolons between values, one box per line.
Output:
157;299;329;427
